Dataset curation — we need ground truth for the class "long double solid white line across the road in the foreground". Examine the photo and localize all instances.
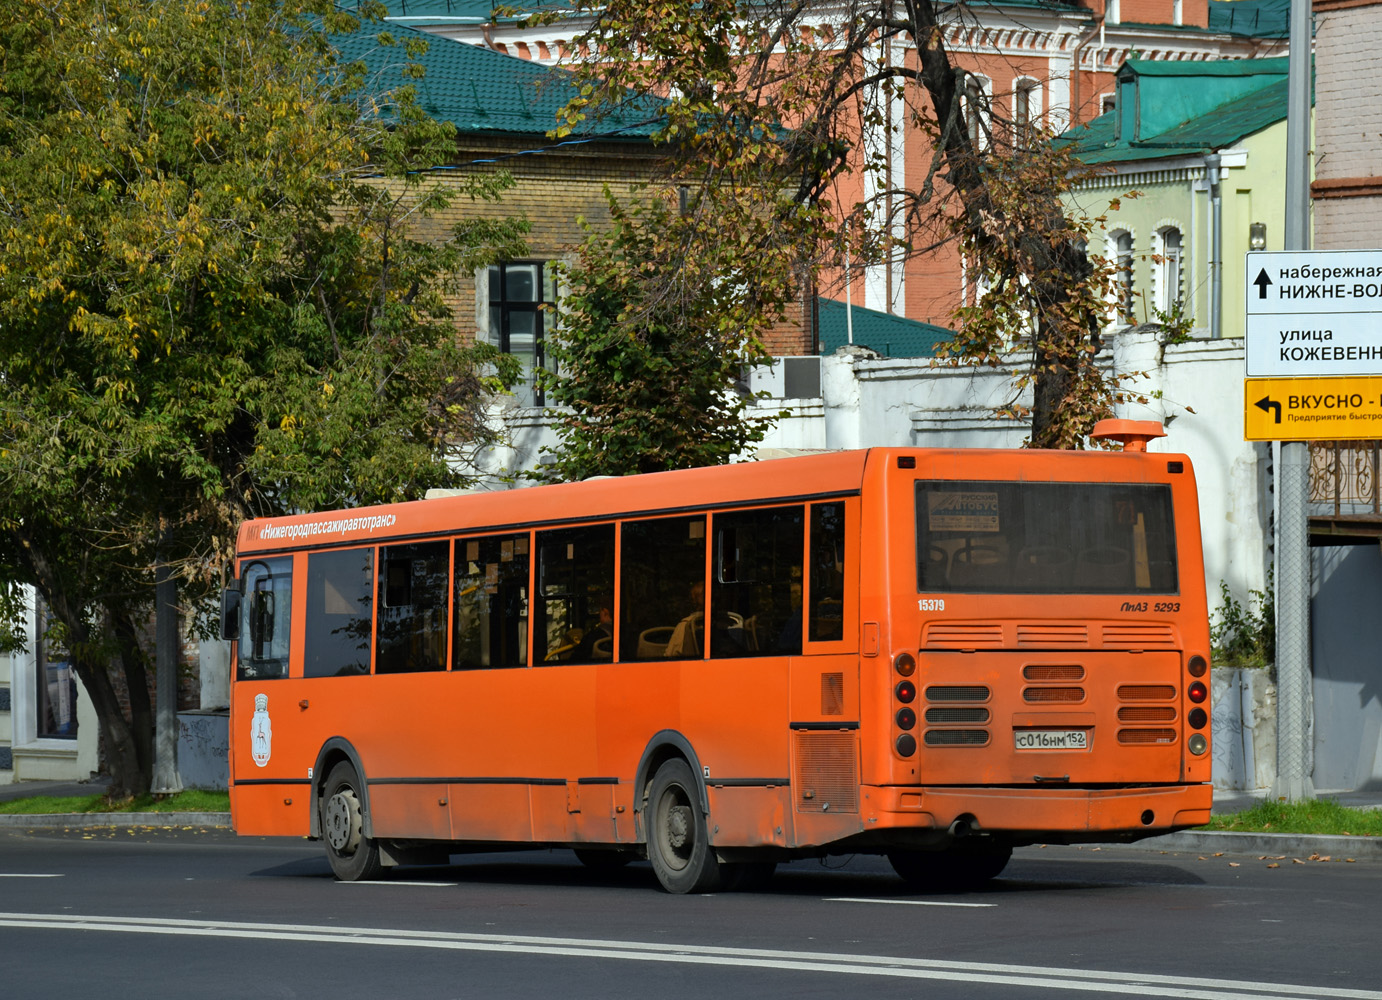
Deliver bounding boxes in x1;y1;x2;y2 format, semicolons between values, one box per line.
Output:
0;913;1382;1000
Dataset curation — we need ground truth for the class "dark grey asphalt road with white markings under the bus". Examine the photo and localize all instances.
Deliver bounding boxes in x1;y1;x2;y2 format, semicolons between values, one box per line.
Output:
0;829;1382;1000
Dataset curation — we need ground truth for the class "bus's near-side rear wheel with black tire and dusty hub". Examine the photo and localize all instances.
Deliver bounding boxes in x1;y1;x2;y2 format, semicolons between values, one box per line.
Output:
644;760;721;895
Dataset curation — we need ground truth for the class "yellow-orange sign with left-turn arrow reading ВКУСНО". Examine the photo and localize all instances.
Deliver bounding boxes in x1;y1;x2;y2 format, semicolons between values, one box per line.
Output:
1242;376;1382;441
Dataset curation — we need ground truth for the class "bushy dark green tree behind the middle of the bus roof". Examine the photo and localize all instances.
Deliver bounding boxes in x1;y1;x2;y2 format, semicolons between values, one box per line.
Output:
543;191;792;479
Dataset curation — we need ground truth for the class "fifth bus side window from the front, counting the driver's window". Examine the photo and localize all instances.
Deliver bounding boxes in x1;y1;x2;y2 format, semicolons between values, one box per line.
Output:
533;523;614;663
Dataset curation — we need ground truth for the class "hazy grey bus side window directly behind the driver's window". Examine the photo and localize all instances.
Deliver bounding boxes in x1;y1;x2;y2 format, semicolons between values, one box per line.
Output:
303;548;375;677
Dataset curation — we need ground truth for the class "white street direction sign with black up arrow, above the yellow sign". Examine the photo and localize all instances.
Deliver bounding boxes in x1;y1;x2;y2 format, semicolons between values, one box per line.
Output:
1245;250;1382;375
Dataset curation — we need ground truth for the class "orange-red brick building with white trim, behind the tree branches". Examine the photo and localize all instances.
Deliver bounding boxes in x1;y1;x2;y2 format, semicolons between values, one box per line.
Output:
386;0;1293;331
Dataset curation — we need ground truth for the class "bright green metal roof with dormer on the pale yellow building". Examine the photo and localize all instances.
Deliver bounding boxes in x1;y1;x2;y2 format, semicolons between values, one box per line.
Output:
1061;59;1287;164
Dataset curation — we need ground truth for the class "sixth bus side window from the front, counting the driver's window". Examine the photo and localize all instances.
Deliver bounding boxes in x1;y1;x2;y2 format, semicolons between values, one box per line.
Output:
619;514;705;660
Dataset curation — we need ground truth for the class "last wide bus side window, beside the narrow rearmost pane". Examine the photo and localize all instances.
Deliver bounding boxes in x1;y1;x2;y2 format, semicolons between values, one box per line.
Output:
710;507;806;659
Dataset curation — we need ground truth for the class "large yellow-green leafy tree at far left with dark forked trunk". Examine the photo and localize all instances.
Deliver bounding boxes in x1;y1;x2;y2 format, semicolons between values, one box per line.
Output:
0;0;524;796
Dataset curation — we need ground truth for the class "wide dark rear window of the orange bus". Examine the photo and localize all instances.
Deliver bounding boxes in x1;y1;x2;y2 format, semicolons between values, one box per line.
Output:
916;481;1179;594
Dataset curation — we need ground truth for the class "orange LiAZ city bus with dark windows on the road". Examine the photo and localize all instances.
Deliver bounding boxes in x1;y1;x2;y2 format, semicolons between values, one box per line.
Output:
223;421;1212;892
